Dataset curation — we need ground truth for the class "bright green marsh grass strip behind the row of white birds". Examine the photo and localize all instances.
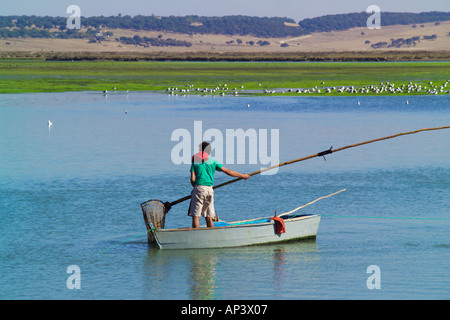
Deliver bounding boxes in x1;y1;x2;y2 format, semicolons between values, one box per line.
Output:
0;60;450;95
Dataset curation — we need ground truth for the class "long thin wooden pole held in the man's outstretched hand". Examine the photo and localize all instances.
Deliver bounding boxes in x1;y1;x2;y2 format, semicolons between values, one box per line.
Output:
166;126;450;208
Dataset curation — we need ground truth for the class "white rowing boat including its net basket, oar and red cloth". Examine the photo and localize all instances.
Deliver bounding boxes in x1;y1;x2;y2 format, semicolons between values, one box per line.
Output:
141;189;345;249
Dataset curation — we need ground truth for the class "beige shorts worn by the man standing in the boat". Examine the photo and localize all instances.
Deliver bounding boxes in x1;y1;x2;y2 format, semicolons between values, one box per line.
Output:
189;186;216;218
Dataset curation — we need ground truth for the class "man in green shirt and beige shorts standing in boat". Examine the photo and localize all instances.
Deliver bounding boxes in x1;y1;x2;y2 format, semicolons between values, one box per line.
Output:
189;142;250;228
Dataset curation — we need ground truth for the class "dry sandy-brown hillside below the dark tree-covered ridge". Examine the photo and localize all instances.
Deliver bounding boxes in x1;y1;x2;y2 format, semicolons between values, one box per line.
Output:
0;21;450;53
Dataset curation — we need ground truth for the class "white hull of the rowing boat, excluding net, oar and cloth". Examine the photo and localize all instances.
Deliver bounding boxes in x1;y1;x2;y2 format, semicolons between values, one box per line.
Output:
151;215;320;249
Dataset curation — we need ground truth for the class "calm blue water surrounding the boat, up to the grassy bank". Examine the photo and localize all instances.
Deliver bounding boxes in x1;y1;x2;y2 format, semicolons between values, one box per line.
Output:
0;93;450;299
